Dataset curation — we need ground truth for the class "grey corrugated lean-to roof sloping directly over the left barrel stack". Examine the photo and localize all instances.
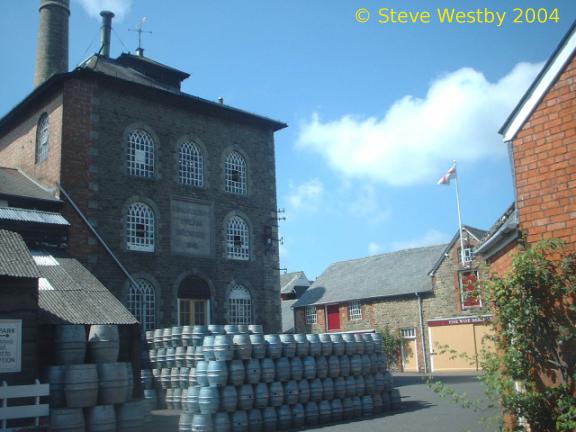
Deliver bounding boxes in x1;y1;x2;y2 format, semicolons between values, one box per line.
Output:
34;253;138;324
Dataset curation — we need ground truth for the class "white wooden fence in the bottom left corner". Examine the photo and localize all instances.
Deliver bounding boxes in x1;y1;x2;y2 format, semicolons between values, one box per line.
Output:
0;380;50;432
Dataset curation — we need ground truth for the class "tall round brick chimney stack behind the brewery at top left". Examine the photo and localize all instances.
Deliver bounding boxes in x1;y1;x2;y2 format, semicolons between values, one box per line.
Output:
34;0;70;87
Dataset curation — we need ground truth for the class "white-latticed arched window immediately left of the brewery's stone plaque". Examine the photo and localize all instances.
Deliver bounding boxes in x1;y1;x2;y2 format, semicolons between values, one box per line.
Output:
126;203;154;252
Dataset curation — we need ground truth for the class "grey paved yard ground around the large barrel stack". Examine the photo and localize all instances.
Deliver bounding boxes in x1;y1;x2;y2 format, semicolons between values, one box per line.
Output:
146;374;498;432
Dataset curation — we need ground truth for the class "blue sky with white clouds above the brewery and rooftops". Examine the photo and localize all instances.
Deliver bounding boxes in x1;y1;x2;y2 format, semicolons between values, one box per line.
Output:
0;0;576;279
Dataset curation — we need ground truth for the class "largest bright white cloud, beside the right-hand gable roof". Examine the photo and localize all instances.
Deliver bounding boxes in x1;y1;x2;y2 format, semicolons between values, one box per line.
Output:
297;63;542;186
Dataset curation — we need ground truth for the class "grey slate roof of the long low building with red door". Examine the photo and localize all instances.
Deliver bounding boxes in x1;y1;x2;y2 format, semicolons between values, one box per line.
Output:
294;245;446;307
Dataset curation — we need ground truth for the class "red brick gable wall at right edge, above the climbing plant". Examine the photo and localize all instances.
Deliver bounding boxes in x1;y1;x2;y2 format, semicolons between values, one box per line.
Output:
512;57;576;245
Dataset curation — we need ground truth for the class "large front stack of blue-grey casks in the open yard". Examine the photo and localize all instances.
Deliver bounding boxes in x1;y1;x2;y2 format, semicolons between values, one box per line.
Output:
161;326;400;432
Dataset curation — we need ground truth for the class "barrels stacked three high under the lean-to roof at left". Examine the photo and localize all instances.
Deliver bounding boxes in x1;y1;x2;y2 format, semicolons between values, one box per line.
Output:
43;325;145;432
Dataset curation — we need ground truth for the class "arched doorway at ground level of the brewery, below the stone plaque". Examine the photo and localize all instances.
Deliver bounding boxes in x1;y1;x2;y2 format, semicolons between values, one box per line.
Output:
178;276;210;325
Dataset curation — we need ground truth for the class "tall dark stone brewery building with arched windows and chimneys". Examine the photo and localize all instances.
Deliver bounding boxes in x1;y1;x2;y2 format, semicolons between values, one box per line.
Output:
0;0;286;332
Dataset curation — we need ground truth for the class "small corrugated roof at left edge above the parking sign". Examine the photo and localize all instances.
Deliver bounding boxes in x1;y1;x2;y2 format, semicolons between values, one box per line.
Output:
0;229;40;278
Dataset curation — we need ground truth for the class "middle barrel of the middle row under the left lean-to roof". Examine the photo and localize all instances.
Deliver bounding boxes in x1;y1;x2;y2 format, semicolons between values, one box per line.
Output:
64;364;98;408
